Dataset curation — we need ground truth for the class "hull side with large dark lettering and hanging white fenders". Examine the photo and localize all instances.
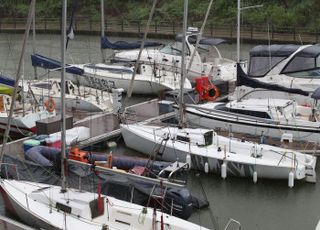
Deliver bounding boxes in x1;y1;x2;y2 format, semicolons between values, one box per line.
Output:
121;125;315;179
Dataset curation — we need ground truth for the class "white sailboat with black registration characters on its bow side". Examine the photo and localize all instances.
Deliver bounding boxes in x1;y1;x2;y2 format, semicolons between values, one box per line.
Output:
69;63;192;95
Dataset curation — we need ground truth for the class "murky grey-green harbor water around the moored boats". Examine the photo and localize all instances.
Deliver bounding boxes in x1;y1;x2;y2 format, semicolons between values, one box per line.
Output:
0;34;320;230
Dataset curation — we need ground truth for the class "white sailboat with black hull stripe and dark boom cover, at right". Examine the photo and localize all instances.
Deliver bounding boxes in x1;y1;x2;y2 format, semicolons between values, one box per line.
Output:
185;66;320;143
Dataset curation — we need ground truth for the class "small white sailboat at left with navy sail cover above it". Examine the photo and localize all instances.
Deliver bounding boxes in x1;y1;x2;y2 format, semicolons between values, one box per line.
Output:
29;54;123;112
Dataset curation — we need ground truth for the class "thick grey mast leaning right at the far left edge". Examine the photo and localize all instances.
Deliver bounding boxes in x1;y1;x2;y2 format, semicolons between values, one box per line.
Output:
0;0;36;163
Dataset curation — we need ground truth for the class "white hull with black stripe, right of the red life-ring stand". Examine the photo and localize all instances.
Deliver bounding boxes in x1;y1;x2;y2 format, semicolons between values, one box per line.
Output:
186;106;320;143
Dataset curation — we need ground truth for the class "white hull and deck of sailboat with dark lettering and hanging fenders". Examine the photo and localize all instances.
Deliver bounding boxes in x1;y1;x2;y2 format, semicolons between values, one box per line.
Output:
121;125;316;179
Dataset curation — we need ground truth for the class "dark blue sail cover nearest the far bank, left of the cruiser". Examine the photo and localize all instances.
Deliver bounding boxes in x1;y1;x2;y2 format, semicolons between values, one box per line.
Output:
101;37;162;50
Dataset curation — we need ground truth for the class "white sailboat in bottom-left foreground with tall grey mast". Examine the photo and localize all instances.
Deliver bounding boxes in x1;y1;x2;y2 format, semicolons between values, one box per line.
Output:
0;0;210;230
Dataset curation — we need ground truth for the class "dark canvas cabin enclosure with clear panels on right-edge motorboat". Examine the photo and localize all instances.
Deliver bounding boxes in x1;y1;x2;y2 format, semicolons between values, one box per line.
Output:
248;44;320;79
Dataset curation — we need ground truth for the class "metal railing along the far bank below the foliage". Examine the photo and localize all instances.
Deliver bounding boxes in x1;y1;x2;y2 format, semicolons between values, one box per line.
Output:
0;17;320;43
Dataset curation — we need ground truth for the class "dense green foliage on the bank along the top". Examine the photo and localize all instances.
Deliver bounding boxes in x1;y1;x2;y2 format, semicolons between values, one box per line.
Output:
0;0;320;29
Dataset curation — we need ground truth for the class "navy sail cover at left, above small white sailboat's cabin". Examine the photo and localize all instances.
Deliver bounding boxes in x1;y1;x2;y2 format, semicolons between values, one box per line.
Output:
31;54;84;75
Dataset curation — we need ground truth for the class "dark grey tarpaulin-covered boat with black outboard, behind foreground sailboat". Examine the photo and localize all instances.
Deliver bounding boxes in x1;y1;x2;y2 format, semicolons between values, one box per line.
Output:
1;155;209;219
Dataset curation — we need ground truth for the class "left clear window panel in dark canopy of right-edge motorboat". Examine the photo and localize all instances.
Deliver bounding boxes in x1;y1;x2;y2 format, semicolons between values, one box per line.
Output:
248;57;287;77
